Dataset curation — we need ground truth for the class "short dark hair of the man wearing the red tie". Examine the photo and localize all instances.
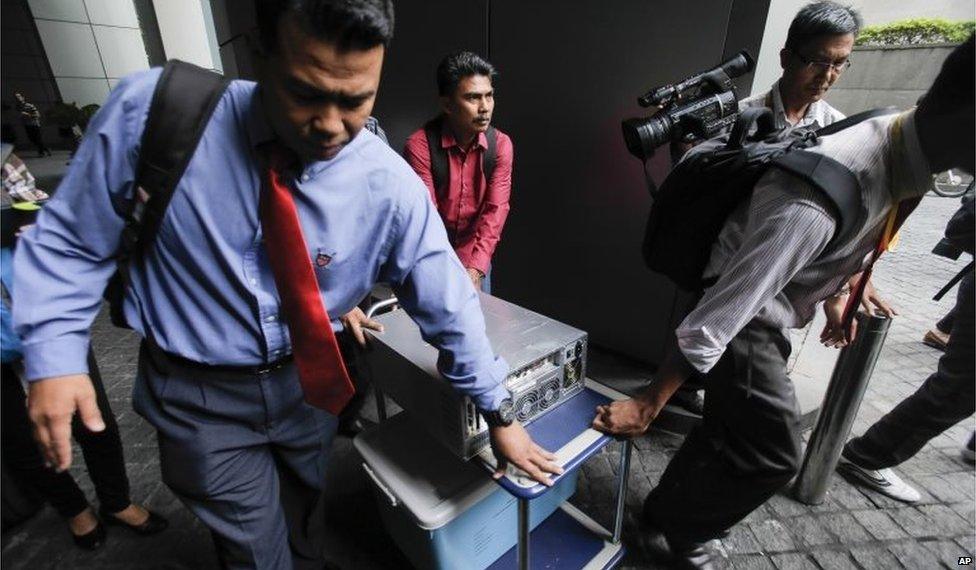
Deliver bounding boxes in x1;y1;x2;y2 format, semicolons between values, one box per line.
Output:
255;0;393;53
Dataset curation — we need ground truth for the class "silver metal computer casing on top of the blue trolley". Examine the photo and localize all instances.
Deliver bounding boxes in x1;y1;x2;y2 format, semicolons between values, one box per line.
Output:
366;294;587;459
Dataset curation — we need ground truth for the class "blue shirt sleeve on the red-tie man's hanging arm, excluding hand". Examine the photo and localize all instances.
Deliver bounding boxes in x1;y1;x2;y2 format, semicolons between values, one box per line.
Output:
14;72;152;381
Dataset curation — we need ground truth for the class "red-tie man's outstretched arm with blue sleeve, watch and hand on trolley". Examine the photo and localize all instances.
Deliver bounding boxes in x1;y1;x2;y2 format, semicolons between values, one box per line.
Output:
387;177;562;485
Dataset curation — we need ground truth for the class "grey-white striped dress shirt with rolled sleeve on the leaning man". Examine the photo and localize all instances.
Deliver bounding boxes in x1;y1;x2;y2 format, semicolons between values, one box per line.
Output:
675;111;932;373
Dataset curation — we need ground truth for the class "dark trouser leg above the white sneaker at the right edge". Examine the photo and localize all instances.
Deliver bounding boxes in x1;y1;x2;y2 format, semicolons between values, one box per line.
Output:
844;273;976;469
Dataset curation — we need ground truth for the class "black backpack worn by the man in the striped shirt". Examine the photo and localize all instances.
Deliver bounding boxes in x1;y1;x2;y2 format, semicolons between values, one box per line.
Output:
643;108;896;292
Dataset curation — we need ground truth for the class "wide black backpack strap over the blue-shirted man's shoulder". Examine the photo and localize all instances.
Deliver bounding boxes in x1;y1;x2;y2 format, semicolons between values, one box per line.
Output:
106;59;229;325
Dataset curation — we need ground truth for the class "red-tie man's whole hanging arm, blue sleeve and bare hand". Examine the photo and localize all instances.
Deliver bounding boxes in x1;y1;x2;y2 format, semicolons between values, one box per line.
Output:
13;70;159;471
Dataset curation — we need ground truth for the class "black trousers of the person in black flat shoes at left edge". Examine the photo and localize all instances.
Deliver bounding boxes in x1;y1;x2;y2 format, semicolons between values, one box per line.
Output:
0;353;130;518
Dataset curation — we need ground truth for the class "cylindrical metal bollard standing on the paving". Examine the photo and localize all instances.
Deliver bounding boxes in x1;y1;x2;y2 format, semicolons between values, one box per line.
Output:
793;313;891;505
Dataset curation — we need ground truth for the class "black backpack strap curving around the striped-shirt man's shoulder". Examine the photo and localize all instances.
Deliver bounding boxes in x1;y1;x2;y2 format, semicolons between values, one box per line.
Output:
770;150;862;243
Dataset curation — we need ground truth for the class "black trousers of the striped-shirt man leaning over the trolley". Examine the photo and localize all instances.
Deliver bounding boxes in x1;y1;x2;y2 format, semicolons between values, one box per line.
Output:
644;322;802;540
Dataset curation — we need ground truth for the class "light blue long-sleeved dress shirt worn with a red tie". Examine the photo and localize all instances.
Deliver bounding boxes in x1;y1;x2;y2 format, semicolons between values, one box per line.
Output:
14;69;508;409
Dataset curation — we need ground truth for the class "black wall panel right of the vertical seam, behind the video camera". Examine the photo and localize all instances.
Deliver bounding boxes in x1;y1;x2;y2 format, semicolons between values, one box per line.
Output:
490;0;765;361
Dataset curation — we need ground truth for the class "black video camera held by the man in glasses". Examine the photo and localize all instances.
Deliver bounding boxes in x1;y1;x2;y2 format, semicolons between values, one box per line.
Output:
621;50;756;160
